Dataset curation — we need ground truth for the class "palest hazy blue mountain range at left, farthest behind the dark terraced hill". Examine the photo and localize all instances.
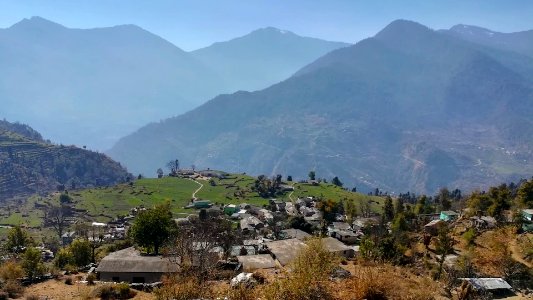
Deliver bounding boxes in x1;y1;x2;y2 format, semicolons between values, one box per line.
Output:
0;17;347;150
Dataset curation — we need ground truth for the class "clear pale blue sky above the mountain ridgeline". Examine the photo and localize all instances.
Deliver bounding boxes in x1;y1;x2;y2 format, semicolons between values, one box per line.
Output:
0;0;533;50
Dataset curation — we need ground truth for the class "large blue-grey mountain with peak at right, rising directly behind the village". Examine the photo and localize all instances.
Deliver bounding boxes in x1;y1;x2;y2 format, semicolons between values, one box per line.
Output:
109;20;533;193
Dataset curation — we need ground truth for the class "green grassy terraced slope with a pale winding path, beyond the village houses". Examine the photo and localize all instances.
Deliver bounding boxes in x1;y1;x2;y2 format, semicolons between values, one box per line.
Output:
0;174;382;227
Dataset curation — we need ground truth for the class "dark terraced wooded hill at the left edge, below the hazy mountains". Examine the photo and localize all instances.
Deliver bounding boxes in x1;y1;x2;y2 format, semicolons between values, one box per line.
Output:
0;120;133;202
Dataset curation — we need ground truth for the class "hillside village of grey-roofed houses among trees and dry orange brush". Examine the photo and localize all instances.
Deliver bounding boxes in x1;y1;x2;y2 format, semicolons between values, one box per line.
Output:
0;169;533;299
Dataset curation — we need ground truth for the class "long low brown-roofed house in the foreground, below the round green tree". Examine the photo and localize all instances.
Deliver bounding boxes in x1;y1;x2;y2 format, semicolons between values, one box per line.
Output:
96;247;178;283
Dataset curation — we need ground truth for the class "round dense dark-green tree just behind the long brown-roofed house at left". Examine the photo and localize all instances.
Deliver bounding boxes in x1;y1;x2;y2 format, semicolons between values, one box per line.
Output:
130;203;176;255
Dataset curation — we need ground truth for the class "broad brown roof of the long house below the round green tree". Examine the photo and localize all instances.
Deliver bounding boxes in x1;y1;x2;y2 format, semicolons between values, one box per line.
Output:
96;247;178;273
